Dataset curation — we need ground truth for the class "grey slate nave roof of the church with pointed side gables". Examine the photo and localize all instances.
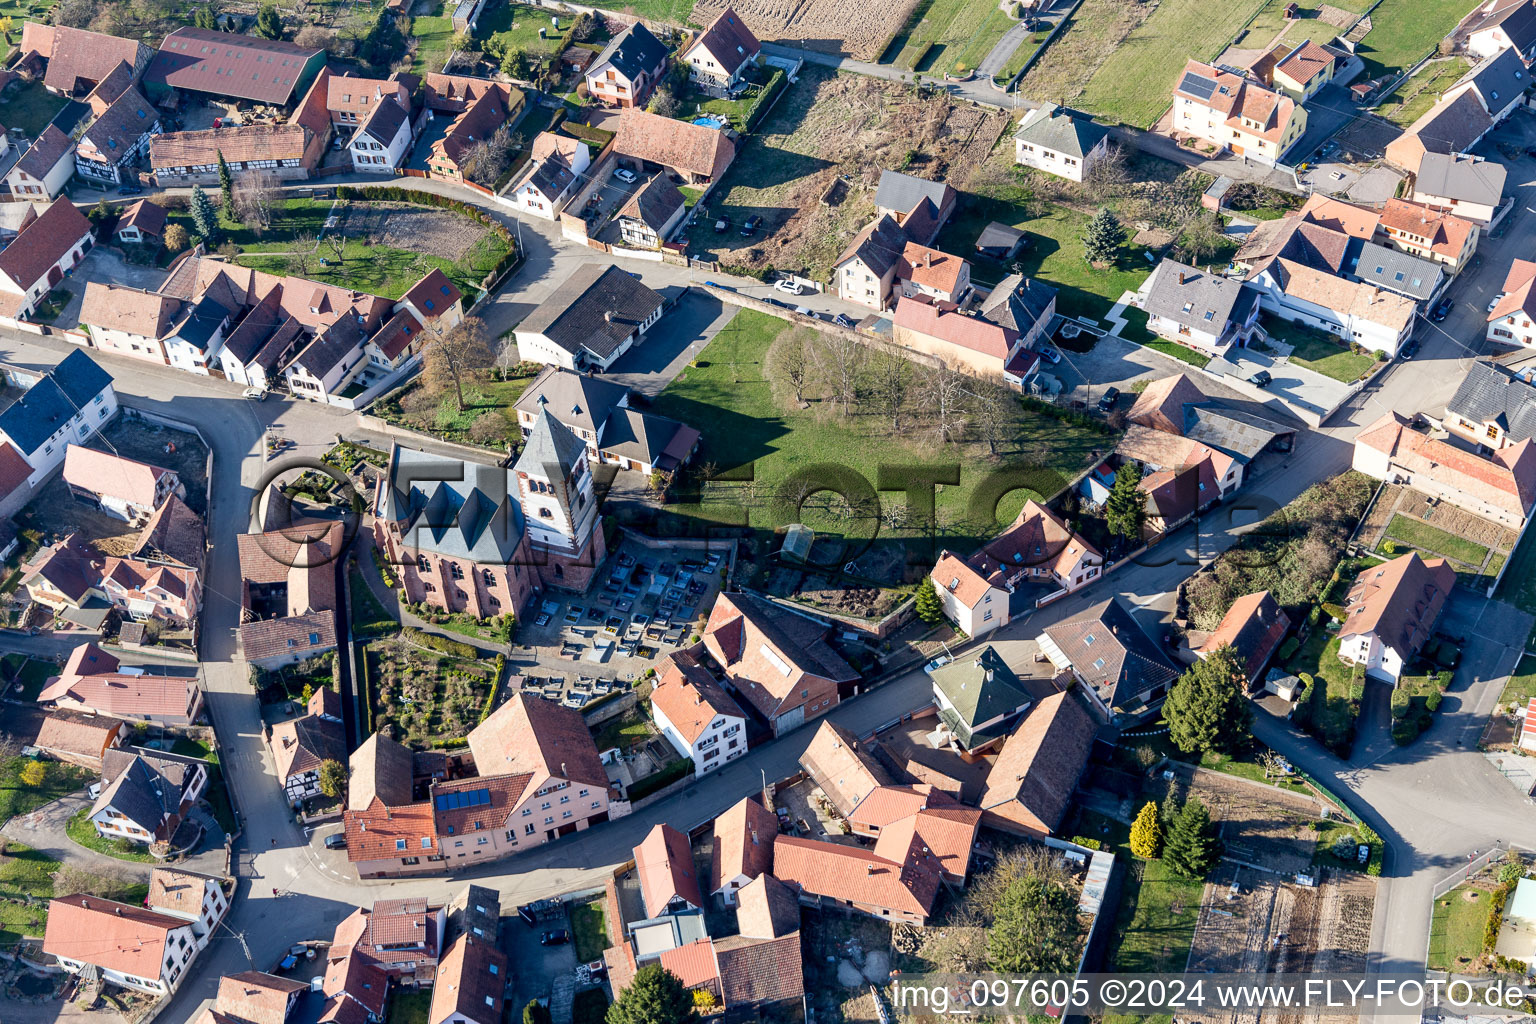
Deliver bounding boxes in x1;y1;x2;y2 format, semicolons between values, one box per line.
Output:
378;445;528;565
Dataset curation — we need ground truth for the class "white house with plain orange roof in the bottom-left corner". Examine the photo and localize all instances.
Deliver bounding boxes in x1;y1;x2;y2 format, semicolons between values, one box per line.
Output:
43;894;198;996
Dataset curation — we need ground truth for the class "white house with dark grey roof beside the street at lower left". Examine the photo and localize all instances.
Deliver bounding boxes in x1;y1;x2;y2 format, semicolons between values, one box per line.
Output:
89;746;207;849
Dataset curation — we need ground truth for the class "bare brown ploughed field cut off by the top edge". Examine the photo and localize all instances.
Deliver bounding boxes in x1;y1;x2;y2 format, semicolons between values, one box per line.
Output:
691;0;915;60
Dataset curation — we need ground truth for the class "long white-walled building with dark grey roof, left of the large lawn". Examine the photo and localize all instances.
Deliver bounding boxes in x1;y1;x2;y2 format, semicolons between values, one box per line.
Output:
516;263;664;373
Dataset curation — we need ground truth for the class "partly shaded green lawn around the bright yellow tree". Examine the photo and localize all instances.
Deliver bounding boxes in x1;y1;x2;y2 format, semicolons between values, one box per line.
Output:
1078;808;1204;973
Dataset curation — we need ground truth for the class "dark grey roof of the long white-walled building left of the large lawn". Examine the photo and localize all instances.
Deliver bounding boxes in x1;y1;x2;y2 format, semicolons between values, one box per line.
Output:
518;263;662;359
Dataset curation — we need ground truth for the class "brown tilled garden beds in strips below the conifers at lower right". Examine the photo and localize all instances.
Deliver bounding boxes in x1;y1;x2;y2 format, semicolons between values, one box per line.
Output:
1186;864;1376;1021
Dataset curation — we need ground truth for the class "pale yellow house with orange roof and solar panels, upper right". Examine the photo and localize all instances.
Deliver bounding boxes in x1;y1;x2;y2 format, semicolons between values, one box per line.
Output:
1174;60;1307;164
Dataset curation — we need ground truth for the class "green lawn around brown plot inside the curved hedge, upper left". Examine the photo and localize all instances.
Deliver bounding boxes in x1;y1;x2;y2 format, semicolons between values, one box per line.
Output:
170;198;507;304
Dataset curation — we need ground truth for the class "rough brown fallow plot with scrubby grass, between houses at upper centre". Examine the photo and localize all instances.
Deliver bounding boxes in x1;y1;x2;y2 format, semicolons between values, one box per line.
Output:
688;66;1008;281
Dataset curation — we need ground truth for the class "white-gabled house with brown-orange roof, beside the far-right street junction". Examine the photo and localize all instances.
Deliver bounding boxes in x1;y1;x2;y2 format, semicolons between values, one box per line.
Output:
1339;551;1456;685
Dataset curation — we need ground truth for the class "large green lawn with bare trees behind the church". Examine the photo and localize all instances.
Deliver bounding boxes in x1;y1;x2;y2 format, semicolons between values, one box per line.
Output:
654;310;1114;550
